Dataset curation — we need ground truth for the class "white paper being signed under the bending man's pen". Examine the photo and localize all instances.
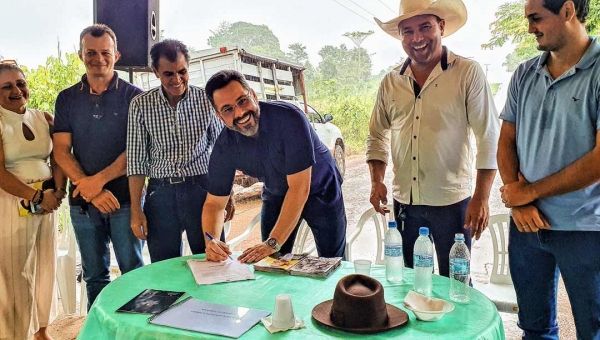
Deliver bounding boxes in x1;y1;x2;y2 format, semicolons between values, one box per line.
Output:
187;259;255;285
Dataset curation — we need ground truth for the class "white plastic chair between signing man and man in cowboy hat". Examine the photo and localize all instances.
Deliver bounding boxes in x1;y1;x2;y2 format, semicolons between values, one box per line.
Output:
346;204;394;264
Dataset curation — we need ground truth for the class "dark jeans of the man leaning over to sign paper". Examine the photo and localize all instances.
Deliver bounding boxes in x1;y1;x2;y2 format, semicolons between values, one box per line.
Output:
261;185;347;259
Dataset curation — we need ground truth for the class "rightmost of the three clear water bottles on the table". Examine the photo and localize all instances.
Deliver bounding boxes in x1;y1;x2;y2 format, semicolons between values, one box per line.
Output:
450;233;471;303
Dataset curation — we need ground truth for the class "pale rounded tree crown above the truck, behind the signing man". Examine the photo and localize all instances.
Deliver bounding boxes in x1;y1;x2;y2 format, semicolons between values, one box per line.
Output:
208;21;285;58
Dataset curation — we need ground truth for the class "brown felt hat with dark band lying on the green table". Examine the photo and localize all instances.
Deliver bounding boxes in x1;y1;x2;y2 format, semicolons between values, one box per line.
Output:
312;274;408;334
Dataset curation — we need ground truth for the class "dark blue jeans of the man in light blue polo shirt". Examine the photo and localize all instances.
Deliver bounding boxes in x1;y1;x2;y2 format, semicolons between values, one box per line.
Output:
508;218;600;339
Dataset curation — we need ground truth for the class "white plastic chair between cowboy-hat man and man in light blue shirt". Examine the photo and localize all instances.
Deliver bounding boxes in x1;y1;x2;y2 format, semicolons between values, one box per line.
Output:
473;214;519;313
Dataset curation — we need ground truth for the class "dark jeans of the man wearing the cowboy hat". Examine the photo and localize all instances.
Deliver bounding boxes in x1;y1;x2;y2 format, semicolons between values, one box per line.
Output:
394;197;471;277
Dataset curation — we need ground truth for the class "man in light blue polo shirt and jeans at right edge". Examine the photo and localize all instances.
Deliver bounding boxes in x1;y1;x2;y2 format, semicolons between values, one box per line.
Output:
498;0;600;339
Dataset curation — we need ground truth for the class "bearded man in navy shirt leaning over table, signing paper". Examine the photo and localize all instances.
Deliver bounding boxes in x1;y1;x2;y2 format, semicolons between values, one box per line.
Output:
202;71;346;263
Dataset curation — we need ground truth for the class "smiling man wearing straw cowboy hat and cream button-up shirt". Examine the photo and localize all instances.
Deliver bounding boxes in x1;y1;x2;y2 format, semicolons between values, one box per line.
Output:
367;0;499;276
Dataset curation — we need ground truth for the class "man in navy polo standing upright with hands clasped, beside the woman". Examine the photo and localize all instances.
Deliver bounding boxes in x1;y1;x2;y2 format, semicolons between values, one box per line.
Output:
53;24;144;308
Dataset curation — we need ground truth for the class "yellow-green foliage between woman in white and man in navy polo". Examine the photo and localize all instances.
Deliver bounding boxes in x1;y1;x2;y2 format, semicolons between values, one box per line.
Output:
23;48;85;113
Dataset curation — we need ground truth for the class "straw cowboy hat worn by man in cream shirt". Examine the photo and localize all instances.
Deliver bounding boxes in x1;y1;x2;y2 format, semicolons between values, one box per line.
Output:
374;0;467;40
